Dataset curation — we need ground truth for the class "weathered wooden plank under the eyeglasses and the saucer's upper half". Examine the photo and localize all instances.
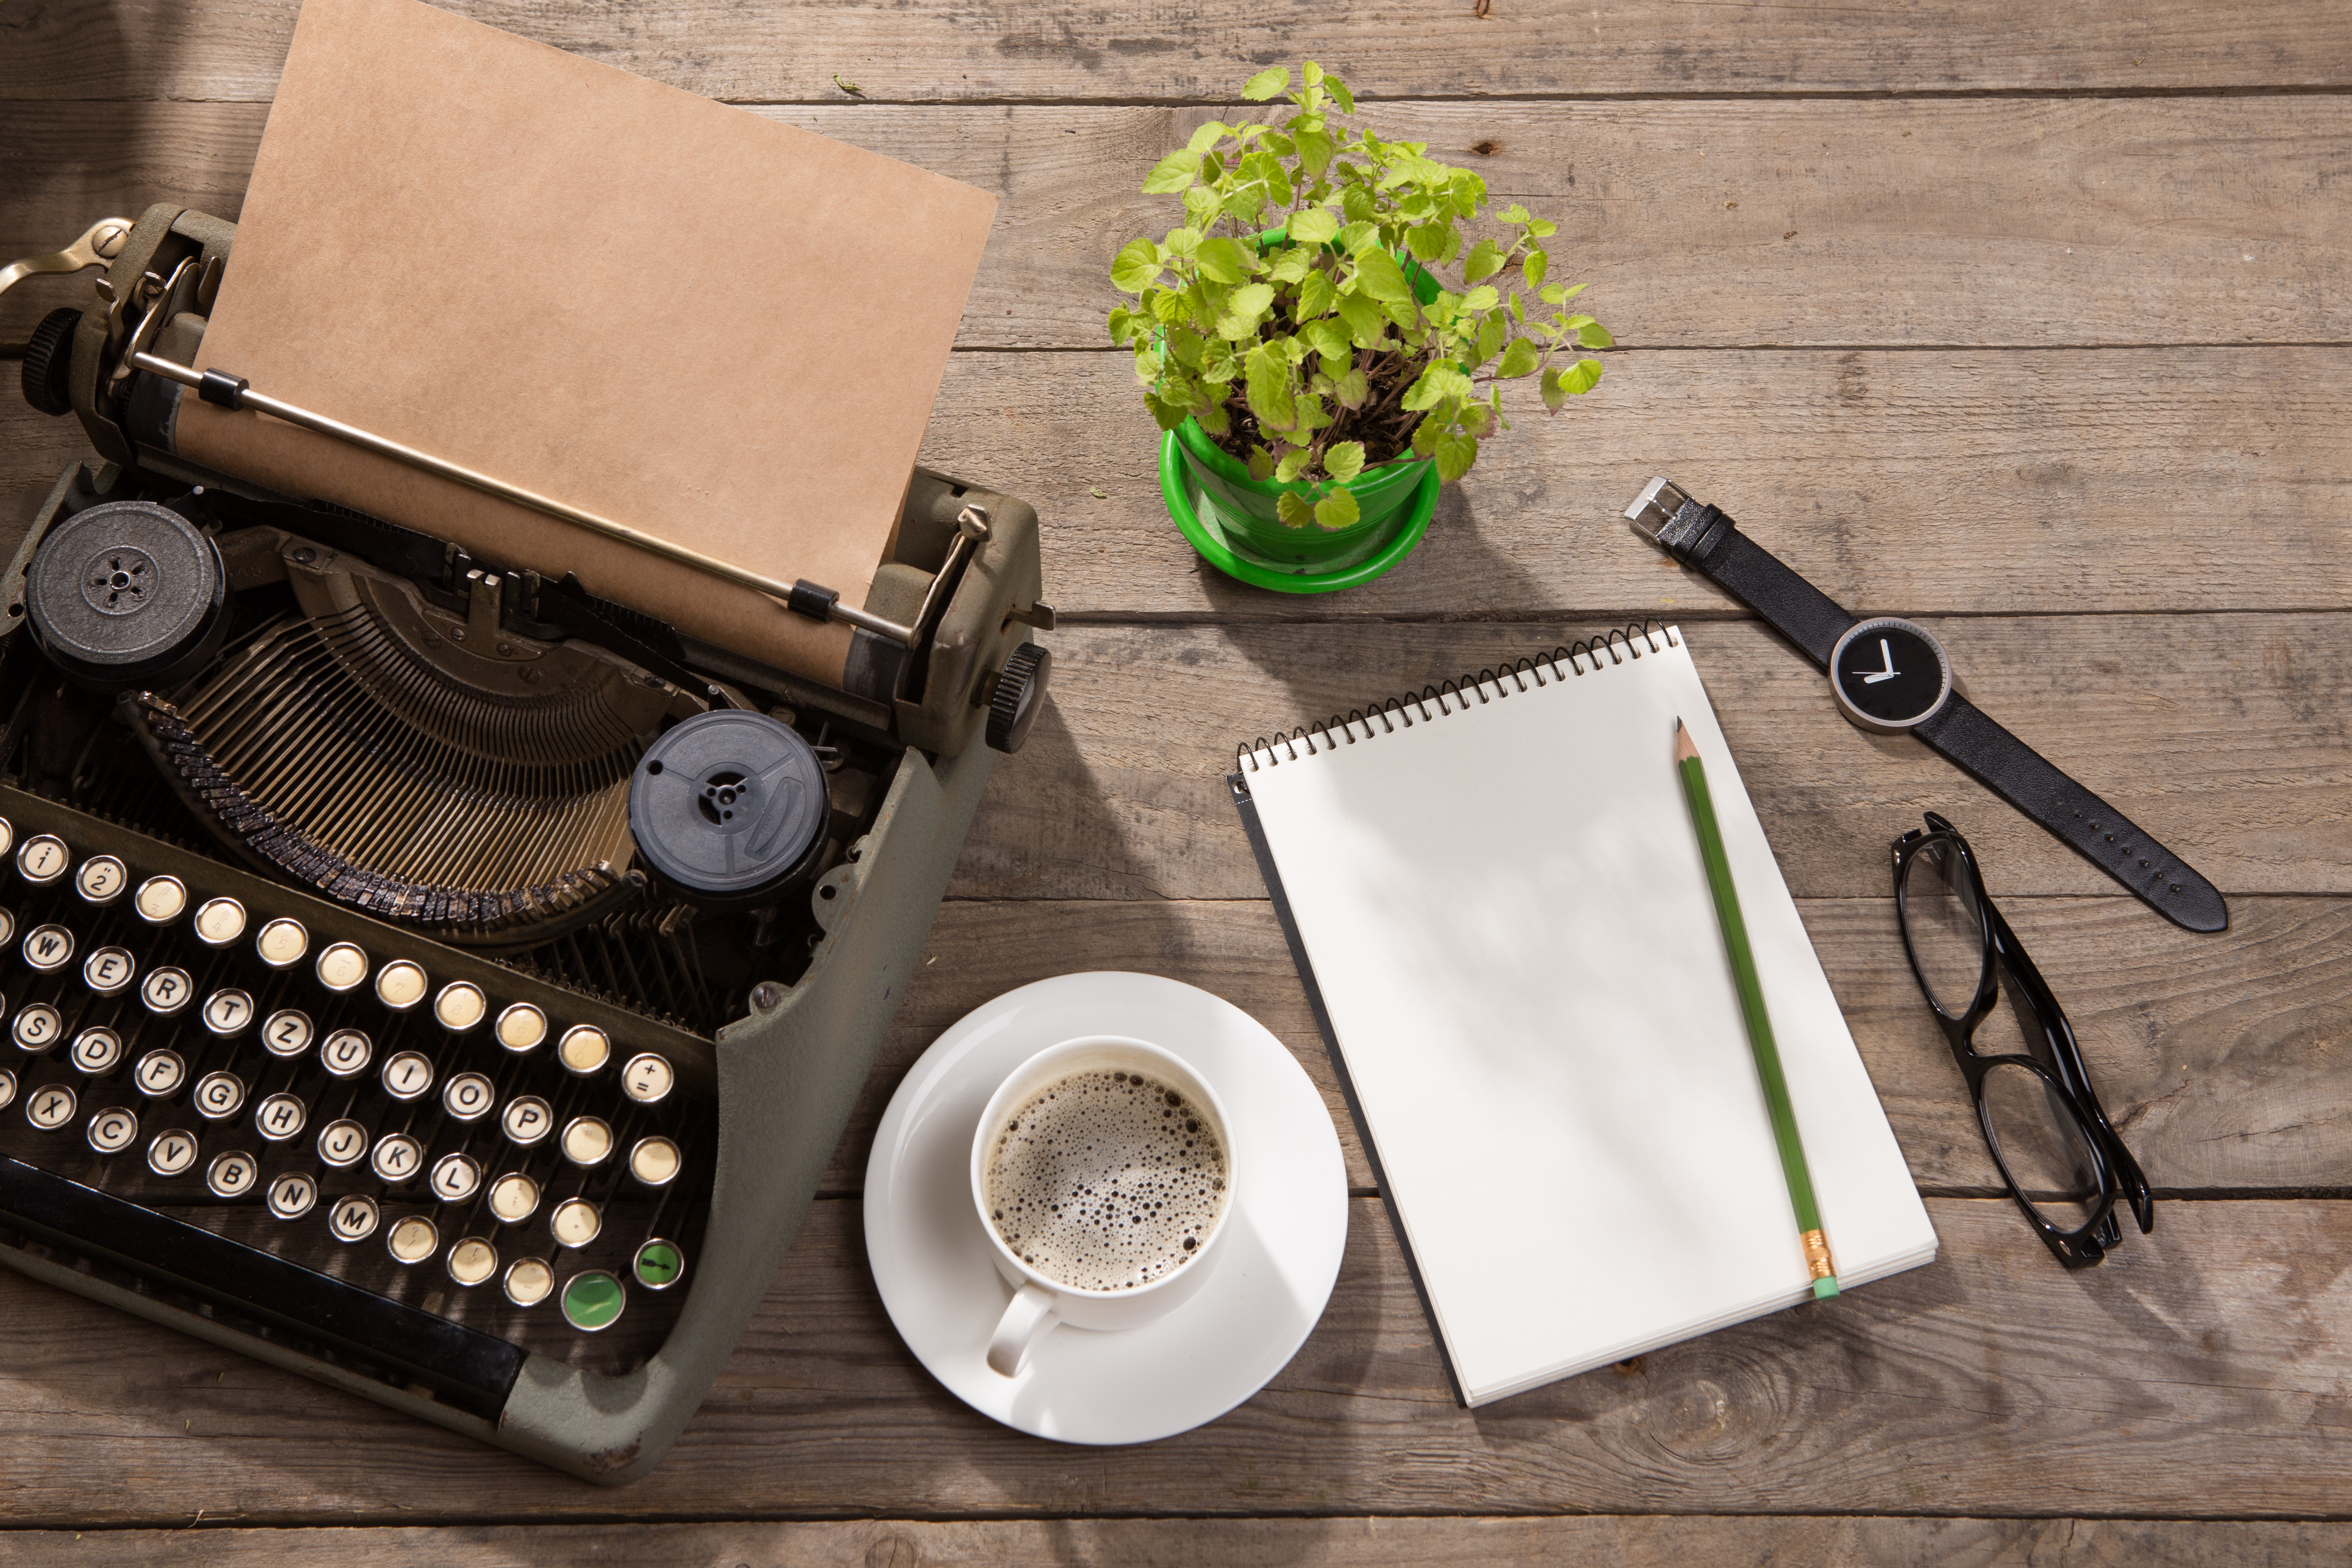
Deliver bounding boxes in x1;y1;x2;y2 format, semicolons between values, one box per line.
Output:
825;898;2352;1194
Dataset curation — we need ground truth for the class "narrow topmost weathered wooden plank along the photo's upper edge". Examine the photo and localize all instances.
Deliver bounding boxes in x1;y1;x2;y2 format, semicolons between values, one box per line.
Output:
0;0;2352;103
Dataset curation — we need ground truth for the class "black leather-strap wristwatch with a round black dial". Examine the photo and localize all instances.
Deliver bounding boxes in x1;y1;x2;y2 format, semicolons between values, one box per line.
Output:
1625;477;2230;931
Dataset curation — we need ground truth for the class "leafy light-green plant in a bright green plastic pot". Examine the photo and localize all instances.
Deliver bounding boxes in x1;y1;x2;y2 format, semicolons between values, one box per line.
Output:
1110;61;1611;592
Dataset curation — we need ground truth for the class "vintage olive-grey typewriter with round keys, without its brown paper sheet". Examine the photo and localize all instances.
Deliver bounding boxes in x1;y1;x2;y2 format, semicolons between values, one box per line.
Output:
0;207;1051;1481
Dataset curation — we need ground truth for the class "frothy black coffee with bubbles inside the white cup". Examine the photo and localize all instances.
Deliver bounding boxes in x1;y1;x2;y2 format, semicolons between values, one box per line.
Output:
986;1069;1228;1291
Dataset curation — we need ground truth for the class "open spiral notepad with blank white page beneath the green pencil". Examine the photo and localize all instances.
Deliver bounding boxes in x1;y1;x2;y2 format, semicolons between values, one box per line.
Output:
1230;628;1936;1406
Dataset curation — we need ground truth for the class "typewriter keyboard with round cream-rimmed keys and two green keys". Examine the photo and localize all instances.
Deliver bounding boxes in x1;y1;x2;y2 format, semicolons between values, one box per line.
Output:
0;790;715;1408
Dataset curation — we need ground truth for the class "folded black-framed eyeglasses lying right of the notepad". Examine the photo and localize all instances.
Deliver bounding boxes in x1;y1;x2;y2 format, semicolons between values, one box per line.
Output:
1893;811;2157;1269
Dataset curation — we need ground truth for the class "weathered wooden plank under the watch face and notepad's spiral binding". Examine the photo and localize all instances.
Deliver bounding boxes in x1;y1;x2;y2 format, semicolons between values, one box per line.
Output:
953;616;2352;902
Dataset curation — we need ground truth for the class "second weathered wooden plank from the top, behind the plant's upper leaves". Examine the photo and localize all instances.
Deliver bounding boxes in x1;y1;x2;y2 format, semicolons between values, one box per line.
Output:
0;97;2352;348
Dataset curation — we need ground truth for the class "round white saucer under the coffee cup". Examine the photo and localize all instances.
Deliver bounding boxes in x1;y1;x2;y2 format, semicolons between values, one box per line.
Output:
866;973;1348;1443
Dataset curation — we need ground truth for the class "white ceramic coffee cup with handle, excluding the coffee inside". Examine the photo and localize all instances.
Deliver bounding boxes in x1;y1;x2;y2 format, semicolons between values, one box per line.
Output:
971;1034;1240;1378
